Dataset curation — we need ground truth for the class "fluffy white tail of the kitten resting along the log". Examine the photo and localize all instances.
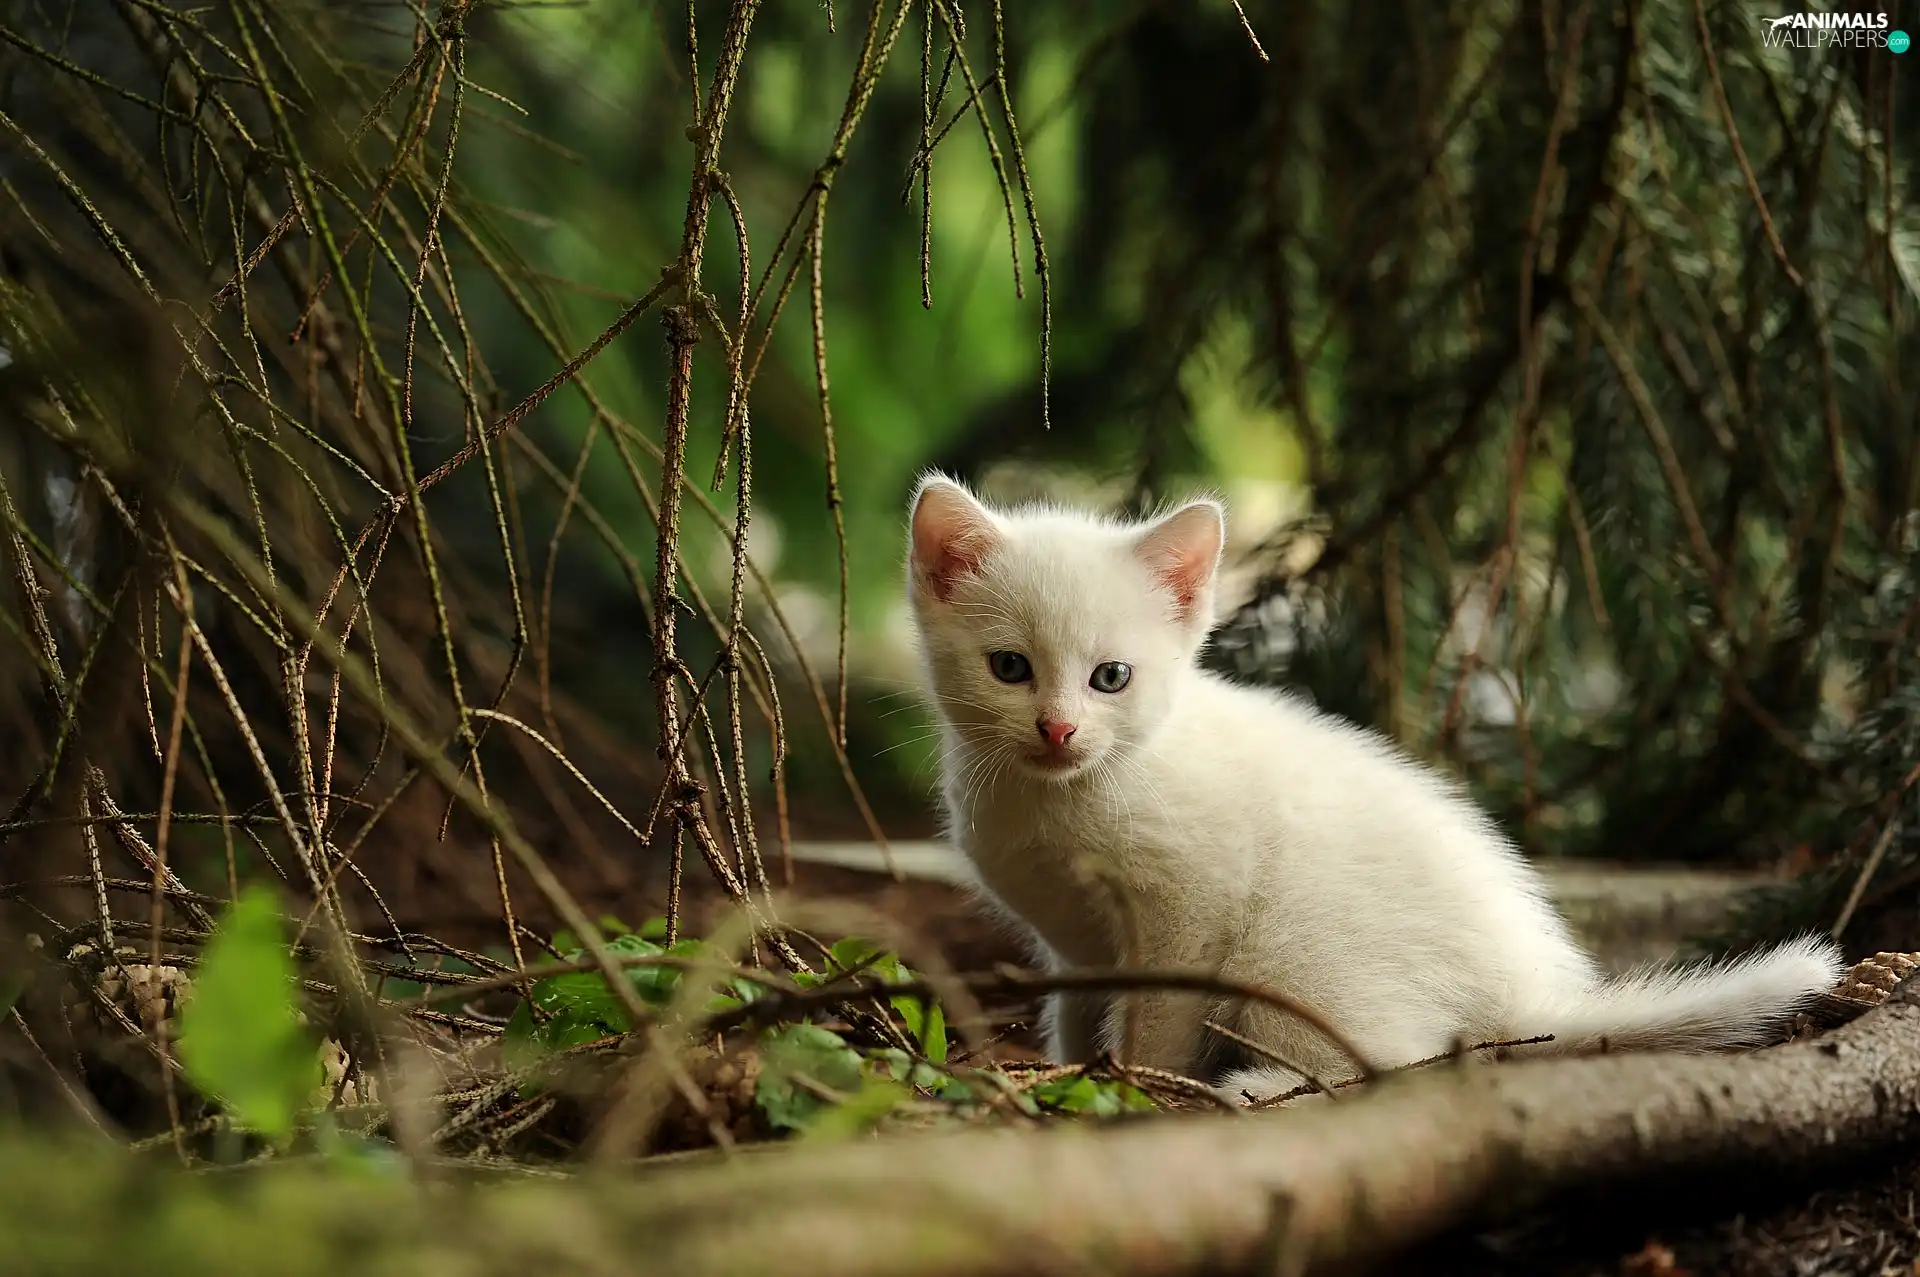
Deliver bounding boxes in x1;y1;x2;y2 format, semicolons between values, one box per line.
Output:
1524;935;1845;1052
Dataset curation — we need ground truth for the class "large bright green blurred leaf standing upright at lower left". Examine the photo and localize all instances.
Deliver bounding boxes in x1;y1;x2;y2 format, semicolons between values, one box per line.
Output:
180;887;323;1143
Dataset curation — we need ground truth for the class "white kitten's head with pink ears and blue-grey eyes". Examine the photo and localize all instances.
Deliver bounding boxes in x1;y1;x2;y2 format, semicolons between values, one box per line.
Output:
906;474;1227;782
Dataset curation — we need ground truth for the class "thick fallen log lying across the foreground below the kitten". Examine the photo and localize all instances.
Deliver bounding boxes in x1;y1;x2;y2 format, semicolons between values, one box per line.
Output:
0;977;1920;1277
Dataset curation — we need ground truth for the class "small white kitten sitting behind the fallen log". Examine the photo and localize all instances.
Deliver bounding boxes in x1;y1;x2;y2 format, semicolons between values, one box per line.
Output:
908;476;1841;1096
